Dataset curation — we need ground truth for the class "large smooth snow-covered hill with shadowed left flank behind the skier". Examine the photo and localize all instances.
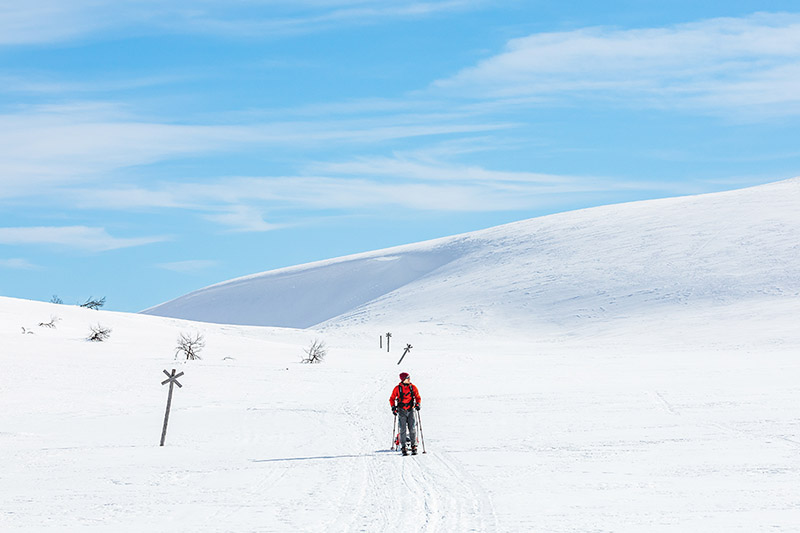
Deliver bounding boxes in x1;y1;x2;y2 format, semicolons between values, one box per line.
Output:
144;178;800;335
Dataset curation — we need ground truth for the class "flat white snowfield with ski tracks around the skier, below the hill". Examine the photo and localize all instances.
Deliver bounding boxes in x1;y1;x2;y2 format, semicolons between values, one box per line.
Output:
0;298;800;533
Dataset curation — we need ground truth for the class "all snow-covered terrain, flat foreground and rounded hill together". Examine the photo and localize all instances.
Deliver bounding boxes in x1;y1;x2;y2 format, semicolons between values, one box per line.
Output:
0;180;800;532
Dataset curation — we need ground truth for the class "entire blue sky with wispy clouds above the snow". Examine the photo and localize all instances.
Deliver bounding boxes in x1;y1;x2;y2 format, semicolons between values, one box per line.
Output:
0;0;800;311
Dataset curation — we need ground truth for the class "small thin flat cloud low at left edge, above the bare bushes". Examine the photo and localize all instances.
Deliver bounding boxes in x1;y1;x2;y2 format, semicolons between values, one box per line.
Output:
0;226;169;252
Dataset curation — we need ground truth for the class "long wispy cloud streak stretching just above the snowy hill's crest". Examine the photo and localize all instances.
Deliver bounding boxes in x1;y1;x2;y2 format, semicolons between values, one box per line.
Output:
57;154;683;217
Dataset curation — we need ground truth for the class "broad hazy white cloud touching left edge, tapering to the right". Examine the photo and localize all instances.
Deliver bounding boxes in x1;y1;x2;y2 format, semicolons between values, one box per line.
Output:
0;104;246;198
